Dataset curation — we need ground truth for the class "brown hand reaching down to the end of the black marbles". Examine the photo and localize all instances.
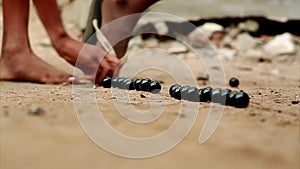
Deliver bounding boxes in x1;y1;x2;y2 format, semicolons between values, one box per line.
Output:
52;35;121;84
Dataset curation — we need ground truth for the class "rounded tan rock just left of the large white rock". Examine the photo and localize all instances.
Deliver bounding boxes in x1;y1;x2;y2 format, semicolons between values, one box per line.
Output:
232;33;258;51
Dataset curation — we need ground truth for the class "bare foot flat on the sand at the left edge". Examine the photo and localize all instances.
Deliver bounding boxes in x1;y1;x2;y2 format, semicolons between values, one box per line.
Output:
0;47;70;84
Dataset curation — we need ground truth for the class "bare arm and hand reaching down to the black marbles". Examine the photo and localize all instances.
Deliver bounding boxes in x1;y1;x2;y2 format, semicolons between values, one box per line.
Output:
33;0;120;83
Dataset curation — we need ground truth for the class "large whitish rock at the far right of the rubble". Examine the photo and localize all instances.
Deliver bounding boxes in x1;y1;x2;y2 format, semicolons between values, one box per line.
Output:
263;33;296;56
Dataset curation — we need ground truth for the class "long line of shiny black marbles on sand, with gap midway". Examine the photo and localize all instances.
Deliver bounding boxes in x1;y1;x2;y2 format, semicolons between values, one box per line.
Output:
102;77;250;108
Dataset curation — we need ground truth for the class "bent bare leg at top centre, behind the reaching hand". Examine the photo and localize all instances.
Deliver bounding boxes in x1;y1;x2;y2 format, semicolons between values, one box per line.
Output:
101;0;158;58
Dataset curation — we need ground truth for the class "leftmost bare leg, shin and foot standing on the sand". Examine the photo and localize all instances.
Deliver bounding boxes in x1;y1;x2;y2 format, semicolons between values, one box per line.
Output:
0;0;70;83
